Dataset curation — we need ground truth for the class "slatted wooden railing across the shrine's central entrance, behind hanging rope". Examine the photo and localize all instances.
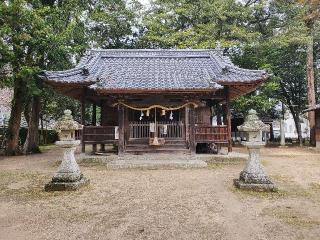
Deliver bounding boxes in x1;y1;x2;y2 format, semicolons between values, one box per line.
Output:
129;122;184;139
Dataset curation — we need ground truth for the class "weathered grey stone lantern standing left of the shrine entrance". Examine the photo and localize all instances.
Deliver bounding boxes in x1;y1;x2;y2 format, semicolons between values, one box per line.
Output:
45;110;89;191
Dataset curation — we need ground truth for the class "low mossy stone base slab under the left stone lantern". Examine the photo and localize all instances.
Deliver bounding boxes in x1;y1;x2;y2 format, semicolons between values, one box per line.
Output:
44;174;90;192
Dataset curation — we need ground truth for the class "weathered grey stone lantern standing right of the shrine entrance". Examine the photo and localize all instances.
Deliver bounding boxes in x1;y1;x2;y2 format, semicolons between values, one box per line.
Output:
234;109;277;191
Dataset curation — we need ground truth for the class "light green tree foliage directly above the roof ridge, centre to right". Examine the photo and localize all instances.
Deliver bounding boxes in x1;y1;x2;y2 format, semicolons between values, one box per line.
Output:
140;0;260;48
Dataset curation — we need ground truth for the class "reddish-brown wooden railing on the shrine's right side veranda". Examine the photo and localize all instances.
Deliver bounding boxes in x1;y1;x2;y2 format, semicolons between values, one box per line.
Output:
195;125;229;143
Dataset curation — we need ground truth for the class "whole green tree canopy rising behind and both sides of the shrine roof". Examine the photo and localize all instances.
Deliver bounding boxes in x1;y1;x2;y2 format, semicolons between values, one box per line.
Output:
0;0;320;154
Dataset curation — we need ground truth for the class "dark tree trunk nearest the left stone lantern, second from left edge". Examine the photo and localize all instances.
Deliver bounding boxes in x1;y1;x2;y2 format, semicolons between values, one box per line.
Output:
23;96;41;154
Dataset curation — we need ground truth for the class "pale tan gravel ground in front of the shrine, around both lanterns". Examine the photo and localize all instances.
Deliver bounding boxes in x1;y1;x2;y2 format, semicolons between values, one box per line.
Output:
0;148;320;240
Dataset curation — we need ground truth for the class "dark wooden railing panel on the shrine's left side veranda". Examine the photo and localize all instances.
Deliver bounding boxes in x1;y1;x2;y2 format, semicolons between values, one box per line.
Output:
82;126;118;144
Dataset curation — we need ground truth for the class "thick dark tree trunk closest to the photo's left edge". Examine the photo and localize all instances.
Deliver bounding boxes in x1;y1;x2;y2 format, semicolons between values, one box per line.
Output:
6;78;26;156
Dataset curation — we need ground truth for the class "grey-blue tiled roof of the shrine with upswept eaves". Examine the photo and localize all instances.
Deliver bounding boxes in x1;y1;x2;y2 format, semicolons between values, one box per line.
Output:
45;49;267;91
